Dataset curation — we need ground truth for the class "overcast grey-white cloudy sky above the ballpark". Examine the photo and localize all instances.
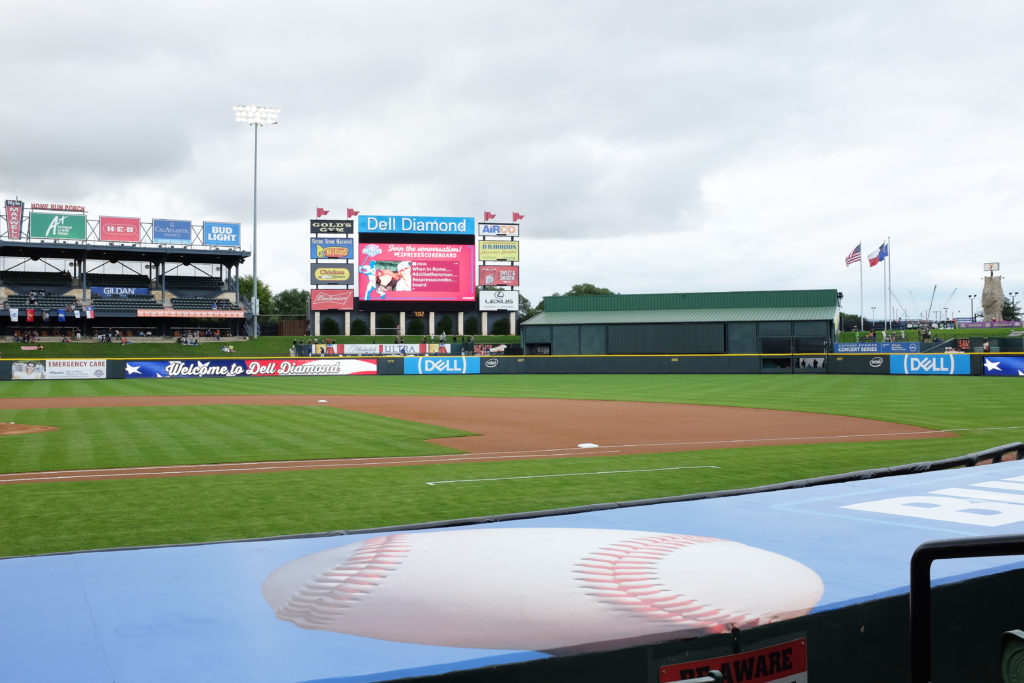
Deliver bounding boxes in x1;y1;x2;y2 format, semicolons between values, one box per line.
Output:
0;0;1024;317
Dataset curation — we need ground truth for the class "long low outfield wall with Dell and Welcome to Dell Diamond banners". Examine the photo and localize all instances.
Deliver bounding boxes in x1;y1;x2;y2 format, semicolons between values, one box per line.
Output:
0;353;1024;380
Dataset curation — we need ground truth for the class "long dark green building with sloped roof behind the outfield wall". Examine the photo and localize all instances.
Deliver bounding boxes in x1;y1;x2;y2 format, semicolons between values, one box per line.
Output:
521;290;839;362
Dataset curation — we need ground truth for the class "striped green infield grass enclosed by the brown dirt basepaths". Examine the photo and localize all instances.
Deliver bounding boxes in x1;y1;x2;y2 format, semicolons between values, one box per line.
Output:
0;404;467;475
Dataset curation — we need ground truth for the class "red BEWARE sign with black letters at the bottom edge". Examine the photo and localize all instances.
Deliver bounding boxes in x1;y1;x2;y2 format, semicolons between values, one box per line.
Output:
657;639;807;683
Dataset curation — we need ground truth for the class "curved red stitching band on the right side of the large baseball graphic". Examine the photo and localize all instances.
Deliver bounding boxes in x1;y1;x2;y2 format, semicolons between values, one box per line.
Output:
574;535;760;633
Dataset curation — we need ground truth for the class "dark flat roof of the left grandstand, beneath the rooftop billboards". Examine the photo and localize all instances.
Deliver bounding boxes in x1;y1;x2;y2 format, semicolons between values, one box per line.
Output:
0;240;249;265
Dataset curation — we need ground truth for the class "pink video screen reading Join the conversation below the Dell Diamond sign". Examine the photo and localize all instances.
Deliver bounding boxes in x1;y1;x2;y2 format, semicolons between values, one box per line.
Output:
358;242;476;301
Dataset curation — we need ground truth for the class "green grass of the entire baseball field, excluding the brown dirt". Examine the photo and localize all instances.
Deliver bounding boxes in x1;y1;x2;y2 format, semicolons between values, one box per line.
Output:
0;375;1024;556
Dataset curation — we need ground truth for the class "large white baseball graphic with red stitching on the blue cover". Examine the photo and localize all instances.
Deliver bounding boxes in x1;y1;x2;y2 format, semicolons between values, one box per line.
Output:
263;528;823;650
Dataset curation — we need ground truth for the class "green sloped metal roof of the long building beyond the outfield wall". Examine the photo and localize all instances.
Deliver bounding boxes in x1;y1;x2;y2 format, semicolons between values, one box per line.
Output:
523;290;839;325
